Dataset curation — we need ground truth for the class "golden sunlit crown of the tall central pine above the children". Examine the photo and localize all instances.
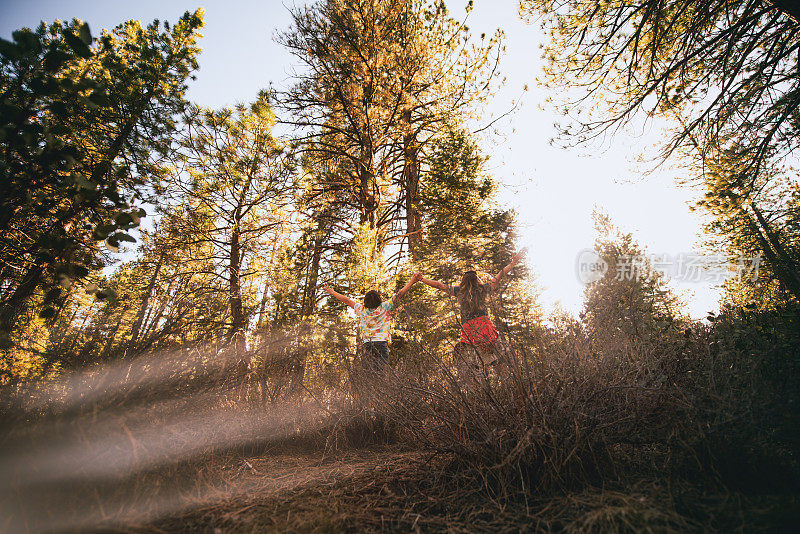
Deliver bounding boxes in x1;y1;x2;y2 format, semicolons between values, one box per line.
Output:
279;0;501;248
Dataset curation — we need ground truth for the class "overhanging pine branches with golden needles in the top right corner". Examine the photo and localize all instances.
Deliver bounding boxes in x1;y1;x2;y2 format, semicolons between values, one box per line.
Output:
521;0;800;174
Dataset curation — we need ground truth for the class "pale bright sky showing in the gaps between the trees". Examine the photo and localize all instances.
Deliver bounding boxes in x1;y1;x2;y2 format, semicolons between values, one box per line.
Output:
0;0;718;317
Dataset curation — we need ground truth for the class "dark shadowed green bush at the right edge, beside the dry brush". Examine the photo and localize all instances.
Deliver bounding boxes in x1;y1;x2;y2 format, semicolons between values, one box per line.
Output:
679;303;800;492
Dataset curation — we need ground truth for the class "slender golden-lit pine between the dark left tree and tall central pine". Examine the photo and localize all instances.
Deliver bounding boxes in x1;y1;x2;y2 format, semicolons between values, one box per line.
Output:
170;97;294;336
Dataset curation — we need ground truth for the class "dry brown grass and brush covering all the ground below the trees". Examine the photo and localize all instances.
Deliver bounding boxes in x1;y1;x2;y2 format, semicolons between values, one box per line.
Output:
0;308;800;532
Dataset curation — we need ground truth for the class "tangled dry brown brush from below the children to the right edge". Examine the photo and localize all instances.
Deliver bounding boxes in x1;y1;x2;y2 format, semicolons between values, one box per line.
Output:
360;306;800;531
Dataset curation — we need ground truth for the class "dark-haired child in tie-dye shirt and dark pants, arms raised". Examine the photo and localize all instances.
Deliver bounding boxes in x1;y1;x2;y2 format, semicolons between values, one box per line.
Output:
323;273;422;368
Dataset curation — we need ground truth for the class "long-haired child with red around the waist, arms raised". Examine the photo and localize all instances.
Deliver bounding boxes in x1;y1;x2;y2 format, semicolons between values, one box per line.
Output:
417;249;525;365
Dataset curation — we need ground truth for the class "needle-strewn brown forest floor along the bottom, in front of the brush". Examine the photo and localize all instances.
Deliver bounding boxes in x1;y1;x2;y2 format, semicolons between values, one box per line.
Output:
134;447;800;534
